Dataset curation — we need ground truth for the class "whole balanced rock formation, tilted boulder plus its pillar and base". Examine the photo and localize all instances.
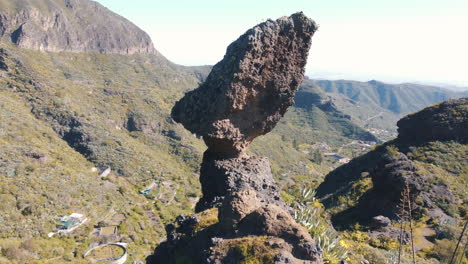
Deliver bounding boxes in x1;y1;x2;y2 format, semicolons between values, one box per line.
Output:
149;13;322;263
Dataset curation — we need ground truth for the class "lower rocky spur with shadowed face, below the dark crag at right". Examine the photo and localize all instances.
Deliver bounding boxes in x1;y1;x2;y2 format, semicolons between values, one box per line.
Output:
317;143;459;236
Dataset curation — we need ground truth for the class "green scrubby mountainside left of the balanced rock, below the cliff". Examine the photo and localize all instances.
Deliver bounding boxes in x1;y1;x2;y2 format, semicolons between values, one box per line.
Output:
0;40;207;263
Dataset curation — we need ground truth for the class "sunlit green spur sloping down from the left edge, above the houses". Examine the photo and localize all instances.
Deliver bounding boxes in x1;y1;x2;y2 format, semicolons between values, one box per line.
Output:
0;89;123;237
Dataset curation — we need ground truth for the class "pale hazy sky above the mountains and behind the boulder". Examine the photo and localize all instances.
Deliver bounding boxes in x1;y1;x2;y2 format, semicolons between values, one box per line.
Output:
94;0;468;86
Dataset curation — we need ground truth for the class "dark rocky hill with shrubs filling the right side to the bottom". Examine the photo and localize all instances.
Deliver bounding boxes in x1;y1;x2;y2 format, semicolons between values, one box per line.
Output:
317;98;468;263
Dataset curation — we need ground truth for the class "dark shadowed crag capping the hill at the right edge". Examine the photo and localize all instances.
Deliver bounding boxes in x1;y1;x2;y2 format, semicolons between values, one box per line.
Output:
397;98;468;142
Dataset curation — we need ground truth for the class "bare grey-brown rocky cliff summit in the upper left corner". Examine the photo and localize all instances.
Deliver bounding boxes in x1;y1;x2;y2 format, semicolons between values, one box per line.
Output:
0;0;156;54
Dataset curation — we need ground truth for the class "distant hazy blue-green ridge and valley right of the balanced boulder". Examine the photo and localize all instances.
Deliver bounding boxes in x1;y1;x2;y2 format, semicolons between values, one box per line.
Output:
312;80;466;141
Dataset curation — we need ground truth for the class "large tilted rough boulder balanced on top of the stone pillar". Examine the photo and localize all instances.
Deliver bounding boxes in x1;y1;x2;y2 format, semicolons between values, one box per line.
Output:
172;13;317;156
